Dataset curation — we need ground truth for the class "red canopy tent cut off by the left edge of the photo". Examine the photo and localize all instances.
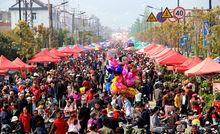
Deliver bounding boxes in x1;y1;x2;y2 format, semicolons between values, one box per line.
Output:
0;55;21;70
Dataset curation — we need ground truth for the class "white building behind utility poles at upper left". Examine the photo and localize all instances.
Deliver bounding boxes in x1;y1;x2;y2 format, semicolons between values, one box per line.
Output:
9;0;61;29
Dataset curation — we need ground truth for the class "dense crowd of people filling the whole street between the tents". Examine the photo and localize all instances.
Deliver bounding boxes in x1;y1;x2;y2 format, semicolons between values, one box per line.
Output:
0;47;220;134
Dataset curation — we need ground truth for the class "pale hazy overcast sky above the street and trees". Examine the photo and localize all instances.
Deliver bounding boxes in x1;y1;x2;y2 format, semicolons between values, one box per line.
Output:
0;0;220;28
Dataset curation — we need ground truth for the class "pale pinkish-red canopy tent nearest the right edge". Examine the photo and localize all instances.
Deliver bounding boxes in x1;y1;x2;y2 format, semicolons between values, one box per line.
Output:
185;58;220;76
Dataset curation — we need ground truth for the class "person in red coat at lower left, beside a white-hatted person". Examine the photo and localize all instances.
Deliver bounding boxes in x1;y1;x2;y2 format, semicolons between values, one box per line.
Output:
19;107;31;133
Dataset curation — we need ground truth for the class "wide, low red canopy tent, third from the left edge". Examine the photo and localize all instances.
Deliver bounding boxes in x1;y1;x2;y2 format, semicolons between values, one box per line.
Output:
28;55;61;63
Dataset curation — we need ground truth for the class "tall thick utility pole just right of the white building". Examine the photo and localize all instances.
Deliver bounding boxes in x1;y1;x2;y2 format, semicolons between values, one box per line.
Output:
48;0;53;48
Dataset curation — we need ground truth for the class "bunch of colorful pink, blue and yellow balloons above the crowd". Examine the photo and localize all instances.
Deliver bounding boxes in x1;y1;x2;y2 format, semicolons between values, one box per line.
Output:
106;60;140;97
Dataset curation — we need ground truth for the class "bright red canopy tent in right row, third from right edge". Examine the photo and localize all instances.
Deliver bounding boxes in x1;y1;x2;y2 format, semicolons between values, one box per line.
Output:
158;52;187;65
